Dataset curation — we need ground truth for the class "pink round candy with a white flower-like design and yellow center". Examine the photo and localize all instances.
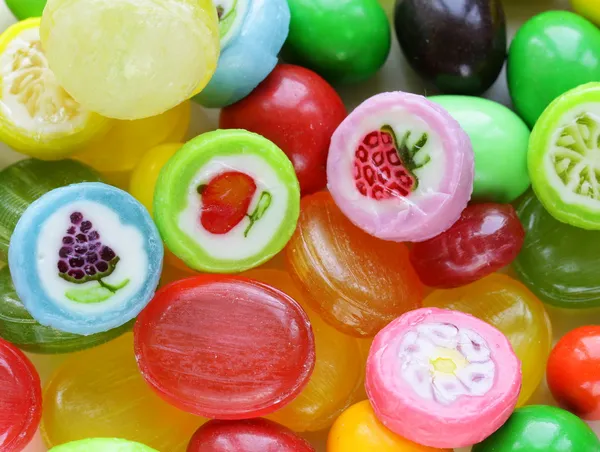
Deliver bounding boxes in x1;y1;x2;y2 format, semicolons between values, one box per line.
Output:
365;308;521;448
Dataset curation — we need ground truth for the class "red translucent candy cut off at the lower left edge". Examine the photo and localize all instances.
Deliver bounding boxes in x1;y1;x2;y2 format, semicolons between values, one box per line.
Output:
0;339;42;452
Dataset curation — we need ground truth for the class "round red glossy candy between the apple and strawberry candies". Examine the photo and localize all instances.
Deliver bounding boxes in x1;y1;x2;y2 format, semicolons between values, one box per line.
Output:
219;64;347;195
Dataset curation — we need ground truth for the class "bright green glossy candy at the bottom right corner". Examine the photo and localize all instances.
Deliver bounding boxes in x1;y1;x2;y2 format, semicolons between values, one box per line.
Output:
473;405;600;452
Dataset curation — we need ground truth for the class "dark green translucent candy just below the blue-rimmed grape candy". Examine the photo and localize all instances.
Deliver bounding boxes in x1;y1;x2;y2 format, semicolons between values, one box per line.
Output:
0;267;133;354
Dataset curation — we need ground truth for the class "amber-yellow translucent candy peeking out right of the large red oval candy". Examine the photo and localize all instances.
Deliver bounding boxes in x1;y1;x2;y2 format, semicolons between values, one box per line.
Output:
243;269;366;432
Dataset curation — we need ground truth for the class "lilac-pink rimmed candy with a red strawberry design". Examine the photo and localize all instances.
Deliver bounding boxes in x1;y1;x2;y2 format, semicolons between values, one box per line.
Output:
327;91;473;242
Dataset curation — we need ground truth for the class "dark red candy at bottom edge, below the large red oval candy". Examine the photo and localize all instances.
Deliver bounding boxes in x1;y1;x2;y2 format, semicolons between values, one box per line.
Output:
187;418;314;452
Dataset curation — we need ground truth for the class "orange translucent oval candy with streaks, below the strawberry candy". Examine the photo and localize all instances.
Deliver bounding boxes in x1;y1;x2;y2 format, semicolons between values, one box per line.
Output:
286;192;423;337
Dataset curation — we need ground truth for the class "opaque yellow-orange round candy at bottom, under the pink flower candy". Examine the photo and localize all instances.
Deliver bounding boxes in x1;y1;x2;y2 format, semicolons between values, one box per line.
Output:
327;400;451;452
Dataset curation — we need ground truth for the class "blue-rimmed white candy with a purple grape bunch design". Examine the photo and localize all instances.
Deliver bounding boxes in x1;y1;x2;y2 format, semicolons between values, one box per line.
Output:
8;183;163;335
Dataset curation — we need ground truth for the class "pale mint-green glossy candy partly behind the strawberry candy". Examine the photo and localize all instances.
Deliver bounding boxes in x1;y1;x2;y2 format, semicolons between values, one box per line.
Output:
429;96;530;203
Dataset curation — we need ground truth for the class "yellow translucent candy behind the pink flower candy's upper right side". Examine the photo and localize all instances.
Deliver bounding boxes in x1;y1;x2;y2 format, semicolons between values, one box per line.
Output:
423;273;552;405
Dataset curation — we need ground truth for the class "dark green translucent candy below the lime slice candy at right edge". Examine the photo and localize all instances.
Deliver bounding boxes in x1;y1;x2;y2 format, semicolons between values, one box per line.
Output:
513;191;600;308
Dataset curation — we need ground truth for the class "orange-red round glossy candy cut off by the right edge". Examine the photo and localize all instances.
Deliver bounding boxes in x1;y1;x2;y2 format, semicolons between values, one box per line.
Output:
546;325;600;421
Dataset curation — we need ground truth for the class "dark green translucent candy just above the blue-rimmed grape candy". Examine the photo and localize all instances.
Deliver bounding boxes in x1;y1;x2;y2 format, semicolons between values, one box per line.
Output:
0;159;102;262
